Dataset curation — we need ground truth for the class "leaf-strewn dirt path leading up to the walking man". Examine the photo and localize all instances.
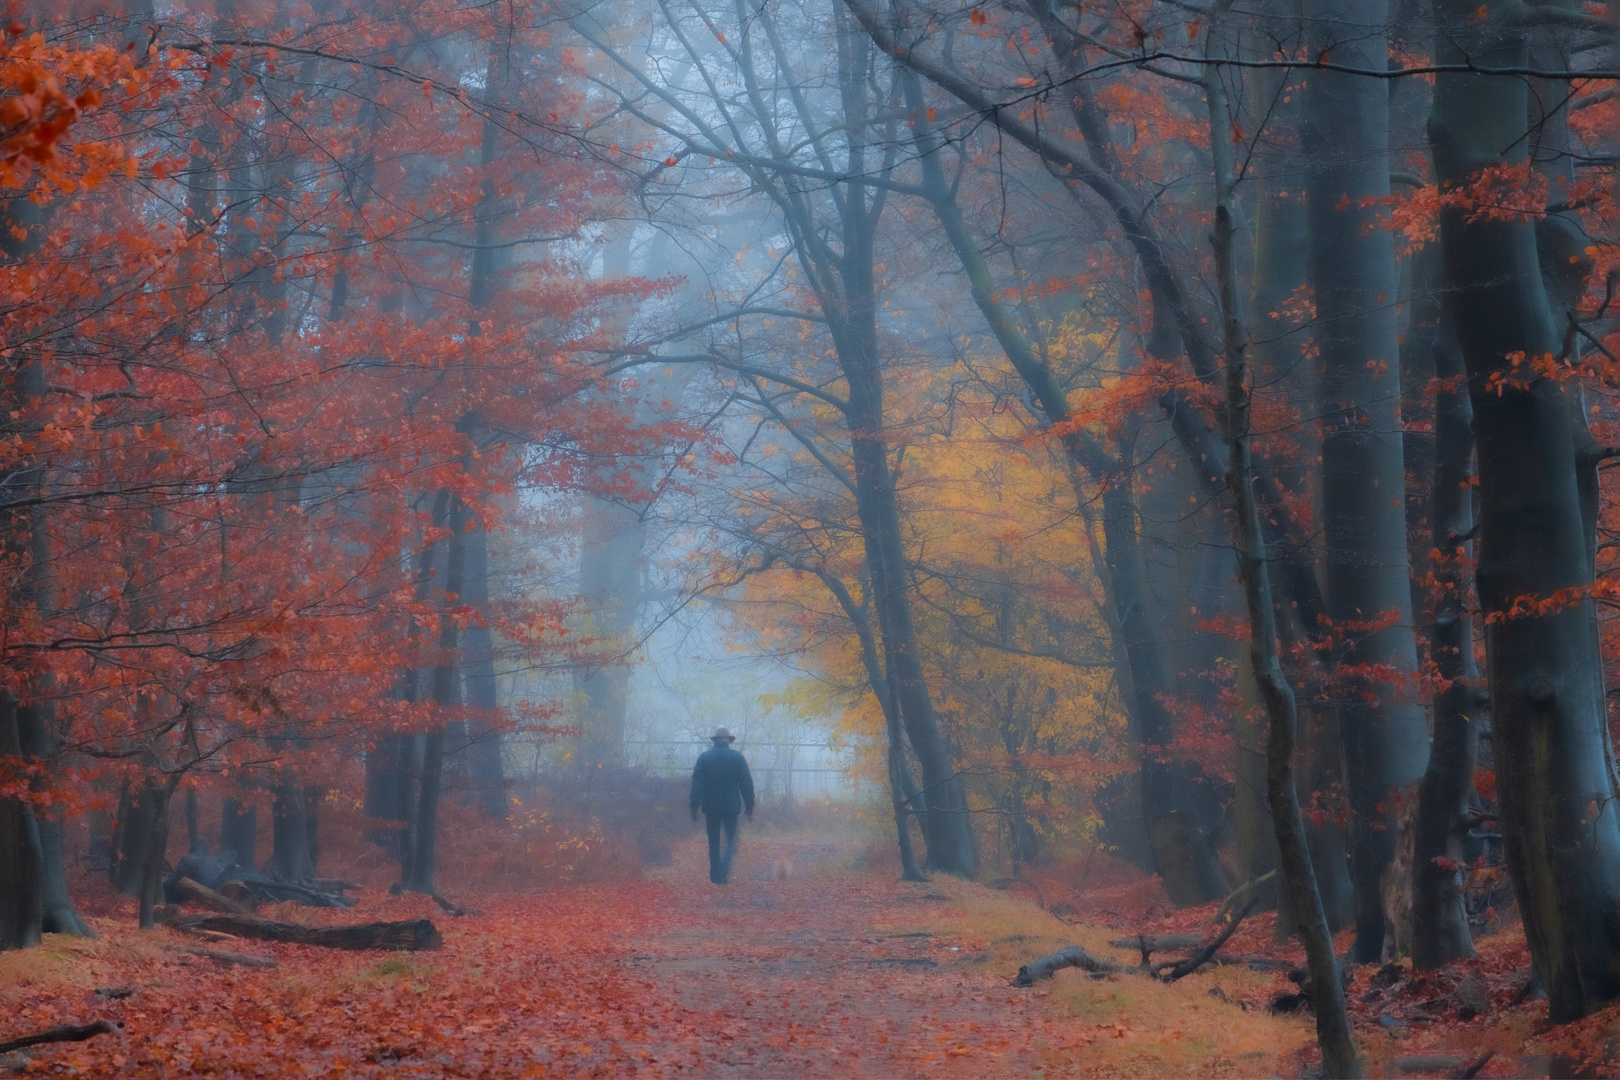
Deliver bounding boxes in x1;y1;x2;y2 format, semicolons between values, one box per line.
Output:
625;837;1047;1077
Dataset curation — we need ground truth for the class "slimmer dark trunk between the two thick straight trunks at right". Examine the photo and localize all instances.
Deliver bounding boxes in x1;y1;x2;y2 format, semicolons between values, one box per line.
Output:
1413;312;1486;970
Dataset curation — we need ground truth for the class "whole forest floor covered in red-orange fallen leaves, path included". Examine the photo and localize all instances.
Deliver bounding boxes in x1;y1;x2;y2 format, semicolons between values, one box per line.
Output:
0;831;1620;1077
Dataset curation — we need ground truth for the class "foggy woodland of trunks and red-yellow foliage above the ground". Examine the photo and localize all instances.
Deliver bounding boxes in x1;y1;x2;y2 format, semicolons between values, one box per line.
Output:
0;0;1620;1075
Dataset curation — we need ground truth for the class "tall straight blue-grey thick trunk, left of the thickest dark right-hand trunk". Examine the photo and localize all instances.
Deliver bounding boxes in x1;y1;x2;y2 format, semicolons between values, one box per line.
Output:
1304;0;1429;962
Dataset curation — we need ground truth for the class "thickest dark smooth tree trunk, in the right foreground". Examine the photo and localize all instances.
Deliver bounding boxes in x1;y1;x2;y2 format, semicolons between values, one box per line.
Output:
1429;0;1620;1022
